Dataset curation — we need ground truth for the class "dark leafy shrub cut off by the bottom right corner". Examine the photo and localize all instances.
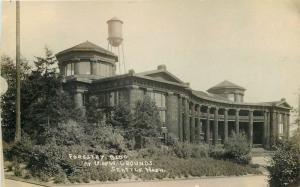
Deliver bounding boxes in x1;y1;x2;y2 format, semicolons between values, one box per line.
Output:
268;140;300;187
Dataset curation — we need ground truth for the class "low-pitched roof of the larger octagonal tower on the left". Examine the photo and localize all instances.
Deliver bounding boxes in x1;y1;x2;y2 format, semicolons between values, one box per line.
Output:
56;41;116;56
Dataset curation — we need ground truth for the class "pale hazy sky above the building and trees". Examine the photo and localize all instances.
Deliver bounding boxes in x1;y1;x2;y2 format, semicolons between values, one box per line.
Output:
0;0;300;107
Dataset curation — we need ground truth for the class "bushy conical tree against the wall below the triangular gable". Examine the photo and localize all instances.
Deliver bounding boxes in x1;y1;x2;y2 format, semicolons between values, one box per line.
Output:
129;96;161;148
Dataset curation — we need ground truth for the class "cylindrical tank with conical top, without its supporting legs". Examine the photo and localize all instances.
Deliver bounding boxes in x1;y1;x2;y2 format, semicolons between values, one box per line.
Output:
107;17;123;47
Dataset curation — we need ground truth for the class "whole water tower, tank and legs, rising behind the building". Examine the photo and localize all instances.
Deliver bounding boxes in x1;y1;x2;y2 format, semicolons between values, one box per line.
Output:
107;17;126;73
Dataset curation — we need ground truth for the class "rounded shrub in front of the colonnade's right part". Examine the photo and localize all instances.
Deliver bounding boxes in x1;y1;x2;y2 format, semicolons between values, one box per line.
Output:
224;133;251;164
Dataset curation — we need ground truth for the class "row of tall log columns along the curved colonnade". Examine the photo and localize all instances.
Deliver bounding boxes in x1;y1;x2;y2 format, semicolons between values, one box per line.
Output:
174;95;289;149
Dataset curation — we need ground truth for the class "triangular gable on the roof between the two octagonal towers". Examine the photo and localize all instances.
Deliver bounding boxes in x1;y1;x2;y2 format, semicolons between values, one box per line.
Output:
137;65;186;84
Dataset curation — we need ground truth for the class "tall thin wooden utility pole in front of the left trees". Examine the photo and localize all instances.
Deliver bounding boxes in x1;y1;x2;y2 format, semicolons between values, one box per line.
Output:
15;0;21;143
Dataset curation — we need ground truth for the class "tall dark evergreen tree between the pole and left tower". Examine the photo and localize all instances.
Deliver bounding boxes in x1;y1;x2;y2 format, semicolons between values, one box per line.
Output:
22;48;81;141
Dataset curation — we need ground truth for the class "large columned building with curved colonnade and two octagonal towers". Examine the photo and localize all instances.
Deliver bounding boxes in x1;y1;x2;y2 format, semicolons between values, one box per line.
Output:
56;41;291;149
